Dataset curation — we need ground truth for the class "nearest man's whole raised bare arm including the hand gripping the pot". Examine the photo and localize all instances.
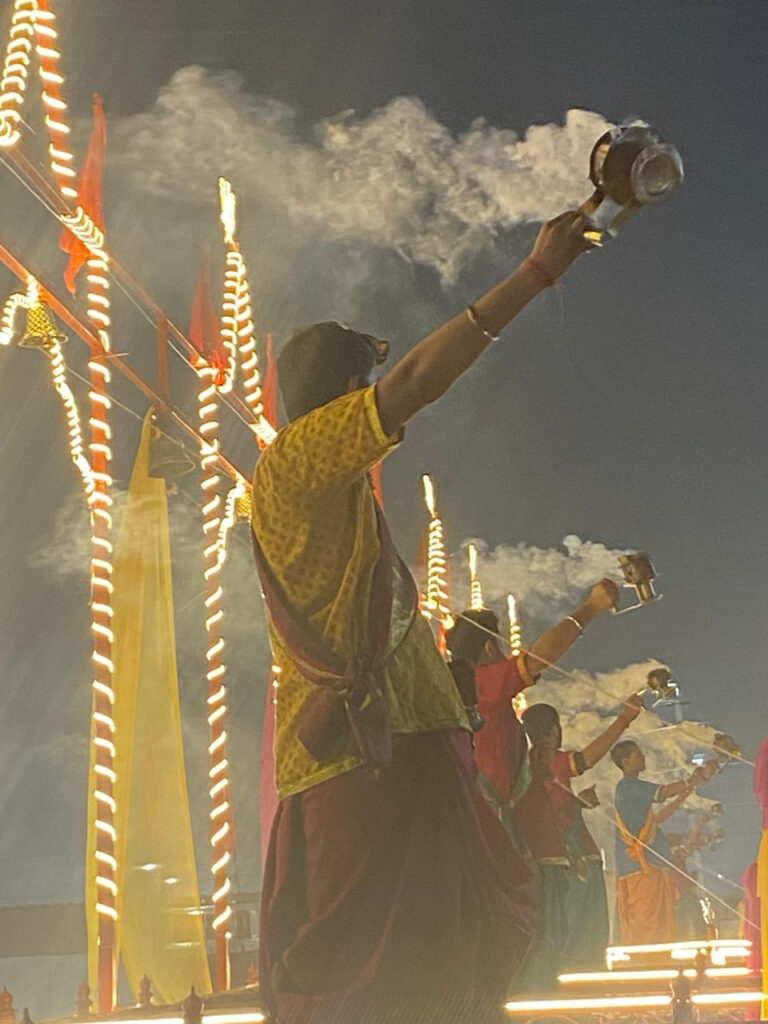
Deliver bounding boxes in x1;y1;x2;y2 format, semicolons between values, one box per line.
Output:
377;211;593;434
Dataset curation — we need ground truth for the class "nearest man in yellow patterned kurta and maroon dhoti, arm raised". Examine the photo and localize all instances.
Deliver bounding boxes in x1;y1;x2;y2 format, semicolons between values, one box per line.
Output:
252;212;591;1024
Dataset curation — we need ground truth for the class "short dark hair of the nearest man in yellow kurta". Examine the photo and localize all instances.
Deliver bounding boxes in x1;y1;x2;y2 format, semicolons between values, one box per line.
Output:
278;321;386;420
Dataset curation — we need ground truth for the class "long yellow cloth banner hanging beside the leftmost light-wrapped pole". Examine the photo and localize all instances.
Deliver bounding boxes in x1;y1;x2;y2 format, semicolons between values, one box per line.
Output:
86;414;211;1002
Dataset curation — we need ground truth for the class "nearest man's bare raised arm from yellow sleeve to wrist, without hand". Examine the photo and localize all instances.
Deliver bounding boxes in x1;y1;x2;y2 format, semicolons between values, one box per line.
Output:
377;265;543;434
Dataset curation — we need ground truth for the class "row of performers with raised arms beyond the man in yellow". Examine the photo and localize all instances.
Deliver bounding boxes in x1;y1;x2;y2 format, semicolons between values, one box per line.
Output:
447;598;719;992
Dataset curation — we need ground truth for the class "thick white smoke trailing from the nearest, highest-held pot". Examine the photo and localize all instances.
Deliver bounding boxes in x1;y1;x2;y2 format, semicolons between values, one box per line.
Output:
112;66;609;282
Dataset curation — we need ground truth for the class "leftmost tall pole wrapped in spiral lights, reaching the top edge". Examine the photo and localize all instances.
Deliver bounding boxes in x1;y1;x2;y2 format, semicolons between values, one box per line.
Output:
0;0;118;1012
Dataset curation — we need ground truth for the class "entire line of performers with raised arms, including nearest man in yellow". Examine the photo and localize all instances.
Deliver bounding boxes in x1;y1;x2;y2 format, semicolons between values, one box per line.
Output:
252;212;733;1024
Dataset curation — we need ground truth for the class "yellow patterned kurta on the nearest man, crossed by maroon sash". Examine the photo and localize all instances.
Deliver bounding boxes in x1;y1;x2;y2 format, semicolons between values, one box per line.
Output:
252;385;468;798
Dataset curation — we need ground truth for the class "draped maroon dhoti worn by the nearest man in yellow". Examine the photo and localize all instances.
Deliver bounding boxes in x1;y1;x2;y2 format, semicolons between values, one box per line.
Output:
260;730;536;1024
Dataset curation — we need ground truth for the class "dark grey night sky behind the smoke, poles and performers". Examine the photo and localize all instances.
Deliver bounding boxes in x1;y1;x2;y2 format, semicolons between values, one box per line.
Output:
0;0;768;925
